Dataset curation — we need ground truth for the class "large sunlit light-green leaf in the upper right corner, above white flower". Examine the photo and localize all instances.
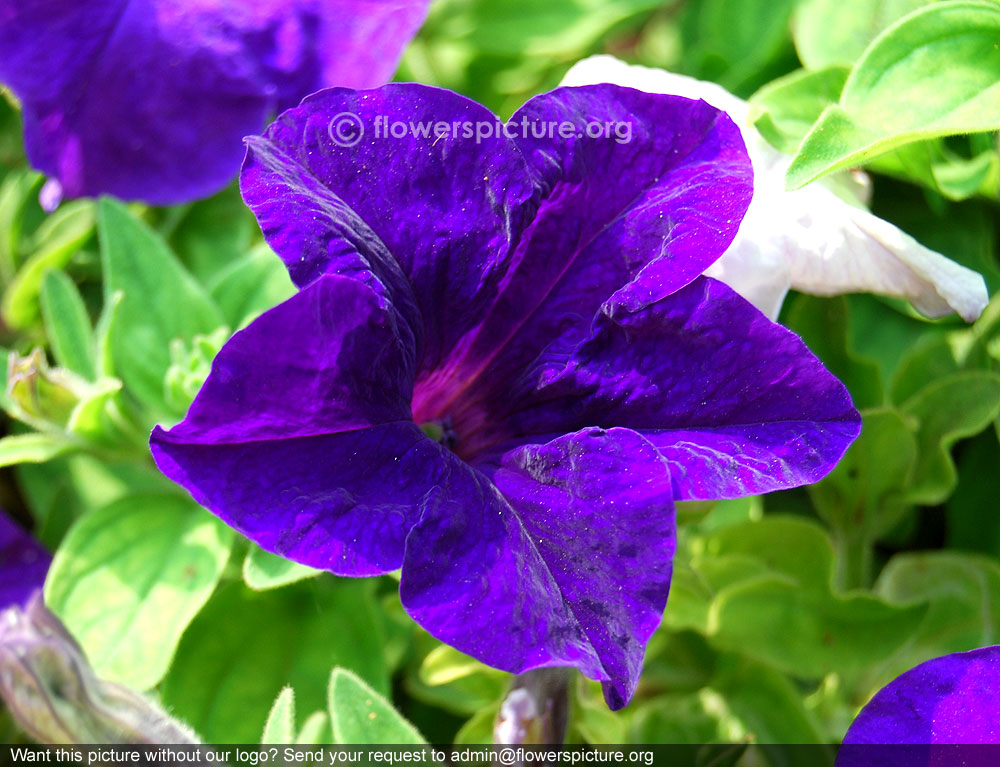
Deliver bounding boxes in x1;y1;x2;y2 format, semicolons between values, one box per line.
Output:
786;0;1000;189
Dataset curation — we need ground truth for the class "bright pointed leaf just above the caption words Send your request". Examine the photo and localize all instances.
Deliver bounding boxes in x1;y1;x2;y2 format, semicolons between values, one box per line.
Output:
330;668;427;745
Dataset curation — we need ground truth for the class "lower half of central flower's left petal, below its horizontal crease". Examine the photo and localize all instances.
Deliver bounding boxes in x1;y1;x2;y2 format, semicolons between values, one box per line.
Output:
151;421;434;575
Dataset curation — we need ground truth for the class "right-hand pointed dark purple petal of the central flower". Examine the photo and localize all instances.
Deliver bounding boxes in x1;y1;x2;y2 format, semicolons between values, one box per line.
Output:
463;277;860;500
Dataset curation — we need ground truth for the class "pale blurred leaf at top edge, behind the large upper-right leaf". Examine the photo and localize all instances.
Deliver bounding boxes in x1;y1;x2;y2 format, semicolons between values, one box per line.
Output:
792;0;930;69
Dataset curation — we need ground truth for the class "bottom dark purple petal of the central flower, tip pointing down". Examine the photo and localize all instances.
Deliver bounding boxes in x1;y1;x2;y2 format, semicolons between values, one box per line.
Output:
400;429;675;708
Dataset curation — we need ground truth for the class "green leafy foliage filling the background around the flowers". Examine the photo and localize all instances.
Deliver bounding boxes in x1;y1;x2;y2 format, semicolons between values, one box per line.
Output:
0;0;1000;764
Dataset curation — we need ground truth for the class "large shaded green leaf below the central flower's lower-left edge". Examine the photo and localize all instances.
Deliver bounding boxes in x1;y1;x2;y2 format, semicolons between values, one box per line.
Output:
161;578;389;743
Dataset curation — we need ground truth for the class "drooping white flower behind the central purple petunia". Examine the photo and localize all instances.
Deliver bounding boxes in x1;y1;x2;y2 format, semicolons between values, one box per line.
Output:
562;56;989;322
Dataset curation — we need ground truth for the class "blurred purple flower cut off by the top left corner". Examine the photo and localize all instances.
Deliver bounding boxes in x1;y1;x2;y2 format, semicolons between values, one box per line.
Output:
0;0;429;204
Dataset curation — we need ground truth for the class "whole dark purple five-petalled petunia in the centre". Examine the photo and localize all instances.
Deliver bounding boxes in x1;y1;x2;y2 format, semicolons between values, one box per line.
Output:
151;85;859;708
